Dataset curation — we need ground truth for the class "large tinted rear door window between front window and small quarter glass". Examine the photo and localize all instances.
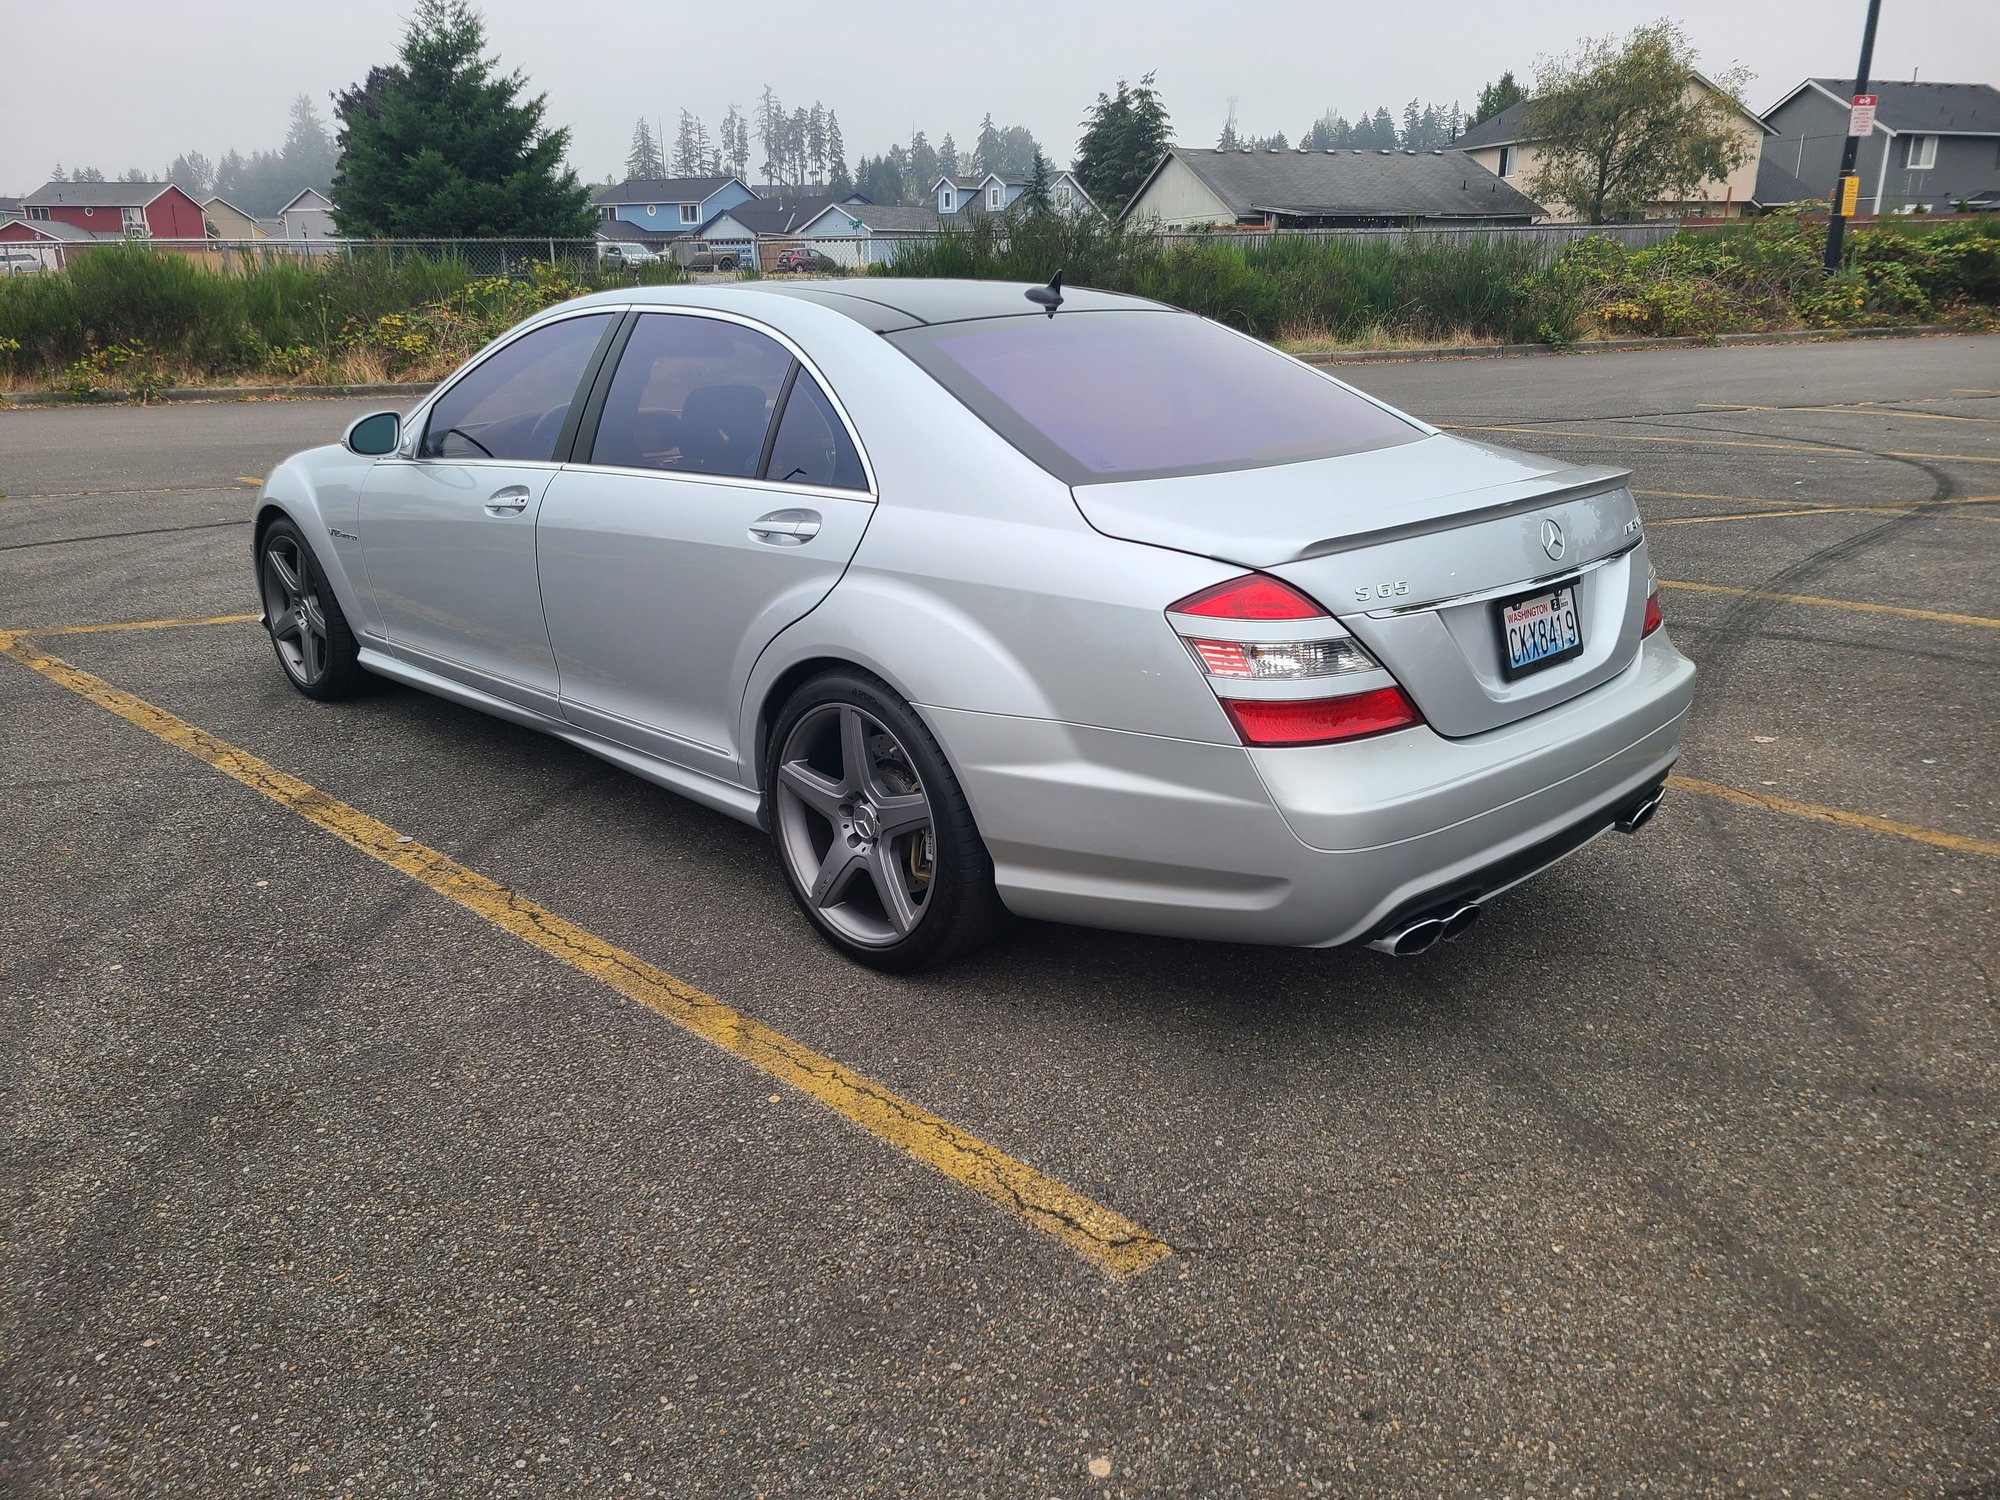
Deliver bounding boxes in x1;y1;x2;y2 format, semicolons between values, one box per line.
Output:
590;312;792;480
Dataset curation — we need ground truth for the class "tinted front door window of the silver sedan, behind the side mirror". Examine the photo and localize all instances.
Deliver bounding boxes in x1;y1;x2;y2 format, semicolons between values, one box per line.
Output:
418;312;616;462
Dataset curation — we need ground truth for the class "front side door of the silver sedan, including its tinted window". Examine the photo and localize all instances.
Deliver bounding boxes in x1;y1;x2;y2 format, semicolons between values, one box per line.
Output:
360;310;620;714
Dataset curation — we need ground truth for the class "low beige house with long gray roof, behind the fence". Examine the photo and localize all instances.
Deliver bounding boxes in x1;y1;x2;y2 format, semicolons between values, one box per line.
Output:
1124;146;1542;230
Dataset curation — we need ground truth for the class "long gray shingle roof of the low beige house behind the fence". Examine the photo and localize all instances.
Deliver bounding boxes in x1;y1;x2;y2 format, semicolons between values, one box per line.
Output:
1174;148;1542;218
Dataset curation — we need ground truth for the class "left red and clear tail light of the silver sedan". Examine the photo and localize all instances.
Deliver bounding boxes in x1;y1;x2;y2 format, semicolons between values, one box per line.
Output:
1166;574;1424;746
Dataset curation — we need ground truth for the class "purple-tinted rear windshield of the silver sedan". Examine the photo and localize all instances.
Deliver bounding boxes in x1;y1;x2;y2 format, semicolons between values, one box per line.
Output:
888;312;1424;484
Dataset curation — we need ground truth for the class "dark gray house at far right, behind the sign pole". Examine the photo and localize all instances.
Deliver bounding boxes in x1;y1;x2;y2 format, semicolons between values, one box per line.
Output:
1764;78;2000;214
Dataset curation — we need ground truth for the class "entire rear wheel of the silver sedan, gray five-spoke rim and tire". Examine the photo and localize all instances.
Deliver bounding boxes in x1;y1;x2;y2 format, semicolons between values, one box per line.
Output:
766;672;1006;972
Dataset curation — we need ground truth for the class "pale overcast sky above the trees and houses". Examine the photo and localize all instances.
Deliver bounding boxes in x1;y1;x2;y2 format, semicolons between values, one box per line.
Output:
0;0;2000;192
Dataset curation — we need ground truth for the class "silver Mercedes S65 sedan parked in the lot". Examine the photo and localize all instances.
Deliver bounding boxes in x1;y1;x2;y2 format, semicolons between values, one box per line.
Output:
254;280;1694;970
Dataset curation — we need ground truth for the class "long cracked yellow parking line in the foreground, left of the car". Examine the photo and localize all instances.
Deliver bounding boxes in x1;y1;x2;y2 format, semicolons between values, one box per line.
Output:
0;638;1172;1276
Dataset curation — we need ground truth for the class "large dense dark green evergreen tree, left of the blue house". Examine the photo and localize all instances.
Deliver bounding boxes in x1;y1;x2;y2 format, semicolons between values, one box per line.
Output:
334;0;590;238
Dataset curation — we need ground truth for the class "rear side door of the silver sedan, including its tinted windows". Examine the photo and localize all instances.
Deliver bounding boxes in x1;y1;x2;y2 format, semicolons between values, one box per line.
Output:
536;312;874;780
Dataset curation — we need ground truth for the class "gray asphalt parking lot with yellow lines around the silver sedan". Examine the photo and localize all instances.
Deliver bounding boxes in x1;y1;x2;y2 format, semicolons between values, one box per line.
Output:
0;338;2000;1496
